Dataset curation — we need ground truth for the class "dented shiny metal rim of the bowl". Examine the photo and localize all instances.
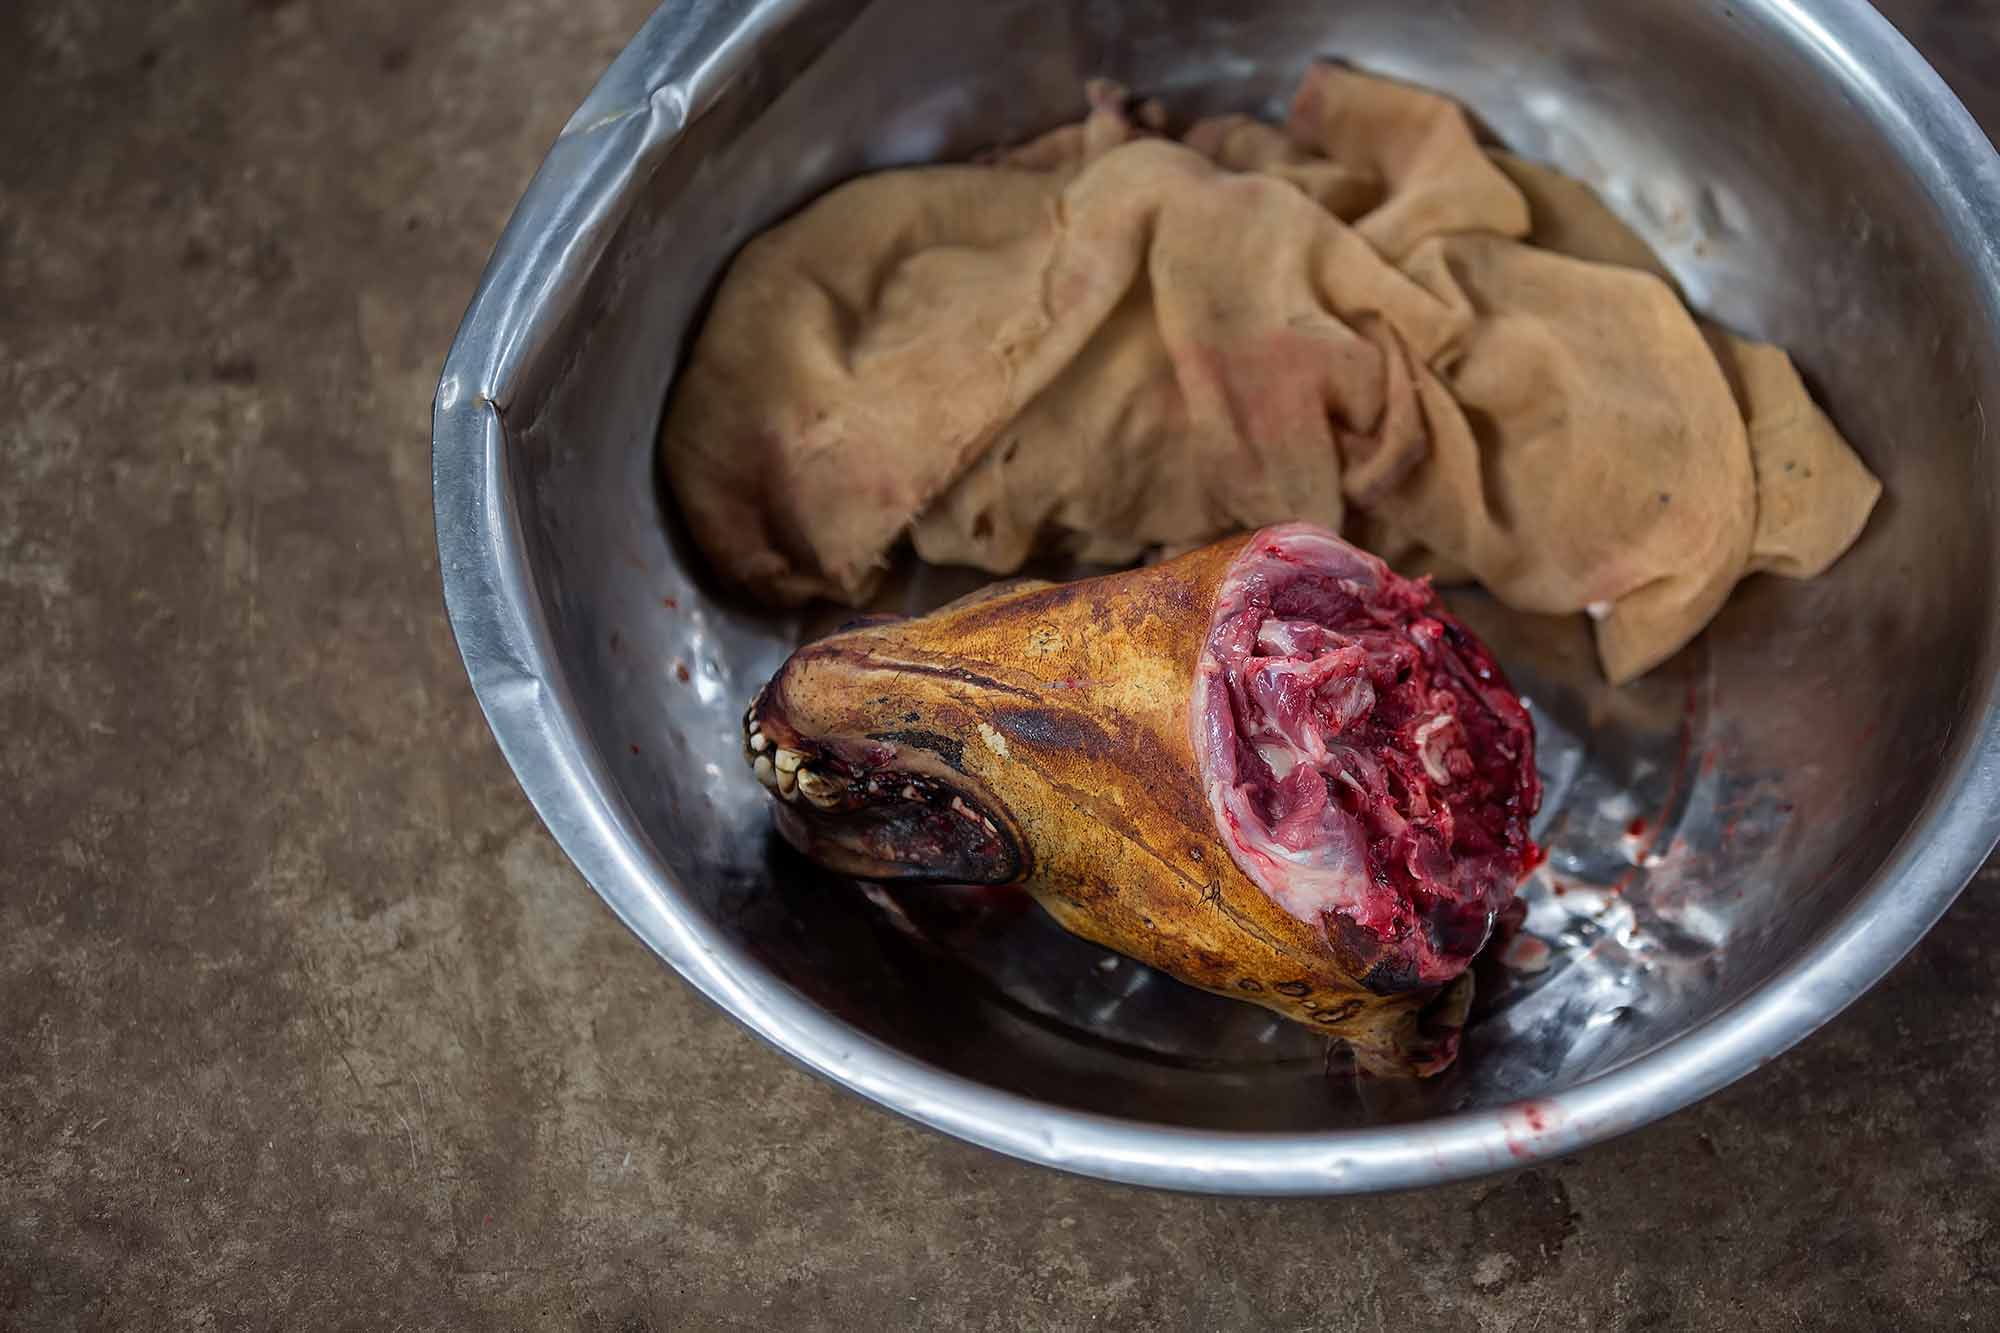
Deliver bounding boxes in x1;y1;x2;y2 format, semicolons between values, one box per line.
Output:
432;0;2000;1195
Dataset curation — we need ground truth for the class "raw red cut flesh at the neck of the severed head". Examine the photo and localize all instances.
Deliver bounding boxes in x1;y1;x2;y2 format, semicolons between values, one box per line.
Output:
1192;524;1542;993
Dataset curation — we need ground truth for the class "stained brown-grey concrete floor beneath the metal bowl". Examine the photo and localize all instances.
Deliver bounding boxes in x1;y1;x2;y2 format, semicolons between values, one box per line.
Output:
0;0;2000;1331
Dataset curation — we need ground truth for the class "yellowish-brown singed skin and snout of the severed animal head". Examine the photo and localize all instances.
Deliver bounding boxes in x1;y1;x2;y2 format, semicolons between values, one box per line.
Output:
744;538;1472;1075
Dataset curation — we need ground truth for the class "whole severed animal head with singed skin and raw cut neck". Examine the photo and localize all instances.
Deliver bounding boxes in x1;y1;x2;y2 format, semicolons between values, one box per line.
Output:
744;524;1540;1073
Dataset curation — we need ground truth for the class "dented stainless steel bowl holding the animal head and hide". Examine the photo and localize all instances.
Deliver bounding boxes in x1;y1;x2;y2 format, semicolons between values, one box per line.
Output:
434;0;2000;1193
